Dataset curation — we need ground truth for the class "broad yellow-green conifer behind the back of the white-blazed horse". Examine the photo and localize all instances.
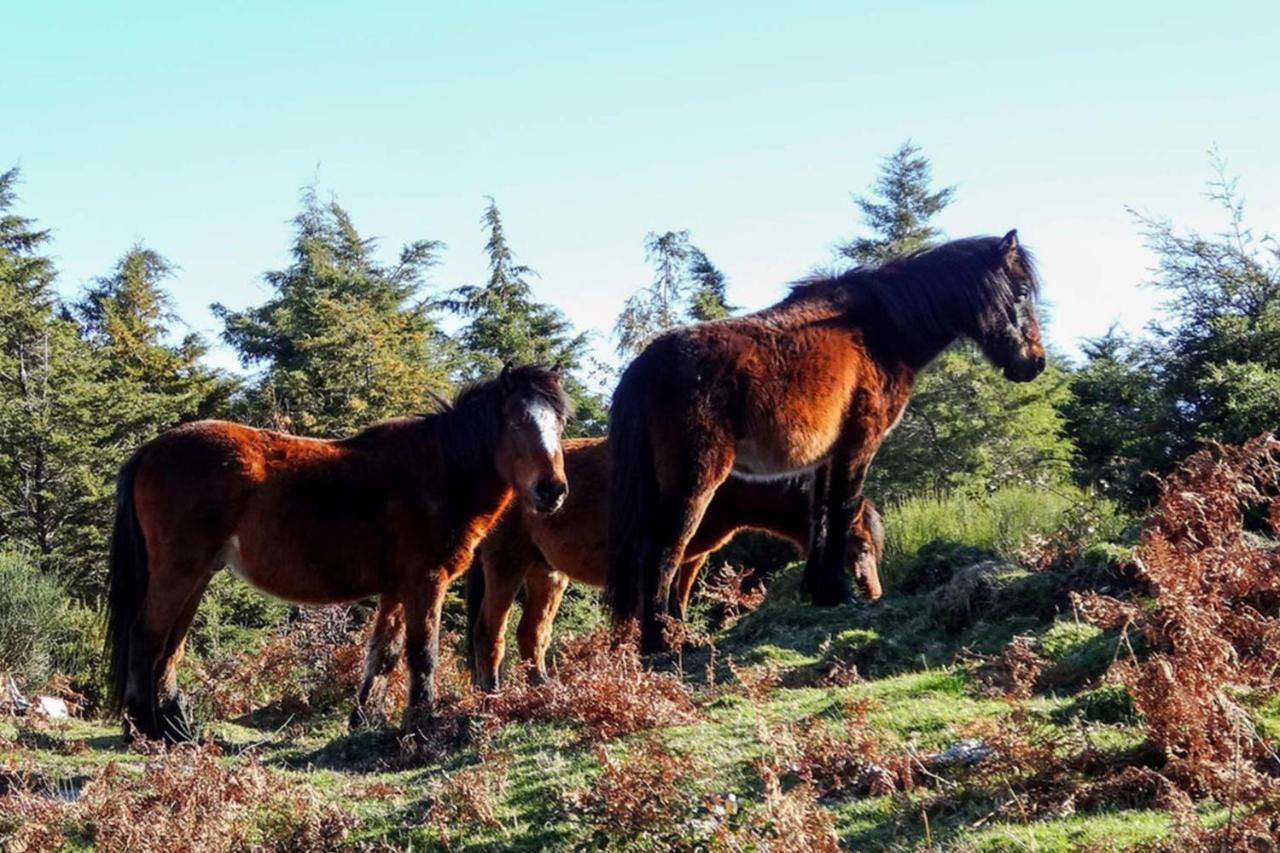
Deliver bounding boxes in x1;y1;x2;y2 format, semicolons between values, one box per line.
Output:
212;190;456;435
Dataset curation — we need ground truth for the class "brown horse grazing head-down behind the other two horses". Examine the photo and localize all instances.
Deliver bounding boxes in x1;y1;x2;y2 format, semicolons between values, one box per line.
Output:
463;438;884;690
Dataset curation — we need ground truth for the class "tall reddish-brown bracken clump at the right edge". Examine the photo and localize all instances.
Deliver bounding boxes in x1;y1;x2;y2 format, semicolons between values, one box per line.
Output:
1076;435;1280;802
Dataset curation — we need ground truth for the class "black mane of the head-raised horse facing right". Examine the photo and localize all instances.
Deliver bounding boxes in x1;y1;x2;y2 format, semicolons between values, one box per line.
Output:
782;237;1039;343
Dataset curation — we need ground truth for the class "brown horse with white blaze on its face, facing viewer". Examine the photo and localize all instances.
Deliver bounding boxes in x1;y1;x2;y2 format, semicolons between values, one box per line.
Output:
108;366;567;739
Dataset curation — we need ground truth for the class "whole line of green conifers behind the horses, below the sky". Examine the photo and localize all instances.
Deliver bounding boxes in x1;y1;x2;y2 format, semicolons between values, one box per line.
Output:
0;143;1280;607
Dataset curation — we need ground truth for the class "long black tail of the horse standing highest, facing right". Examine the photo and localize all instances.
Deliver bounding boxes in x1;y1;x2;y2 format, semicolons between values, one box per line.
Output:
604;362;658;624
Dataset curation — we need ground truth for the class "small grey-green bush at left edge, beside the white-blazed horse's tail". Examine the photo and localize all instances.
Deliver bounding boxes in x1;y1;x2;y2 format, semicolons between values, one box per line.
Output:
0;551;77;692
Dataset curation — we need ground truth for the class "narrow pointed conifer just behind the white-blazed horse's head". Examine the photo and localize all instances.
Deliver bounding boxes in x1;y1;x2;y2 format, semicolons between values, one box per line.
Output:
442;199;608;435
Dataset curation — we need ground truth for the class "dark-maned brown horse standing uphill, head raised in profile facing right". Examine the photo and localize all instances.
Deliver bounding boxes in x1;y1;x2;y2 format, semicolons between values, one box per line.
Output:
605;232;1044;652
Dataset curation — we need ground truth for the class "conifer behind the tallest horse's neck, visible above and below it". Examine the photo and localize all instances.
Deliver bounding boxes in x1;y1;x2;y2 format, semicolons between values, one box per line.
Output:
837;142;1071;500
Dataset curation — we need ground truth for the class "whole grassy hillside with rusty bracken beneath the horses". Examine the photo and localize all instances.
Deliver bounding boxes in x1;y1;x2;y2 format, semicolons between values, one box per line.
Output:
0;448;1280;850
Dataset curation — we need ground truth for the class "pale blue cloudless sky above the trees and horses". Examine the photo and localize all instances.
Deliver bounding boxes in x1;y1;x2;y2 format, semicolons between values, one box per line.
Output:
0;0;1280;376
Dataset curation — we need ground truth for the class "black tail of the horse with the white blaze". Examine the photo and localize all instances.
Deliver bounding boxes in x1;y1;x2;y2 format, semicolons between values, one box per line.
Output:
106;453;147;712
